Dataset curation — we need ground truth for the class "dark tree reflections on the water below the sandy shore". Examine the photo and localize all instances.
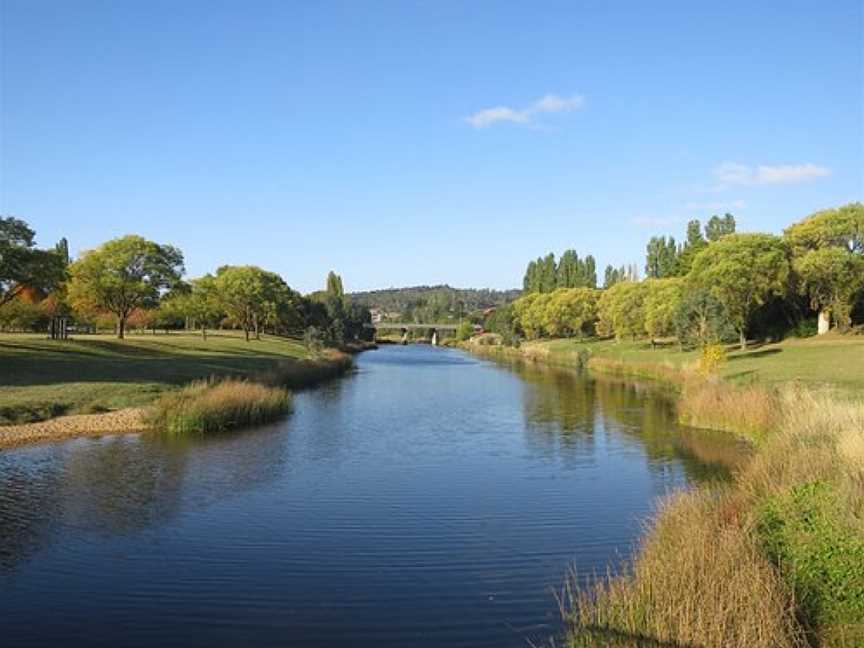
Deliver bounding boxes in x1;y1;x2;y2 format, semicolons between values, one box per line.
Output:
0;426;286;568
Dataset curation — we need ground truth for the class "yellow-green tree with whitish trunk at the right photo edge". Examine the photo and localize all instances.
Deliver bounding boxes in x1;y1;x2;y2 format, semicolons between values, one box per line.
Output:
793;247;864;334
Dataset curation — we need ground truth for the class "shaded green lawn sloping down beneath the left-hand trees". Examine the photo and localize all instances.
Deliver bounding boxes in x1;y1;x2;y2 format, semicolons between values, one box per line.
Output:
0;331;307;424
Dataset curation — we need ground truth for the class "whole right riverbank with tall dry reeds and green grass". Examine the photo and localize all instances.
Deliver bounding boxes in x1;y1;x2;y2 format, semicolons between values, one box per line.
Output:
472;336;864;647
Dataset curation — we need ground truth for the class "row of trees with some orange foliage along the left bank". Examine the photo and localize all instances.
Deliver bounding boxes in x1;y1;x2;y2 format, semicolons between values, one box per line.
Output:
0;217;372;346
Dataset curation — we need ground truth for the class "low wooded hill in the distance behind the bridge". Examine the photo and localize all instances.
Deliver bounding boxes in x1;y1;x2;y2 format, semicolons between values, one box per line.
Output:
350;285;522;322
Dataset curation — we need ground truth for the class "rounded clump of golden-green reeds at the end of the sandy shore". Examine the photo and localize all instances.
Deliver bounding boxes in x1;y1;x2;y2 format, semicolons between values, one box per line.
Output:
148;378;291;434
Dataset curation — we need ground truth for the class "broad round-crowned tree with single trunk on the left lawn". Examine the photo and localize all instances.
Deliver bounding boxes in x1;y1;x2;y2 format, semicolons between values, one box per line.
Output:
68;235;183;339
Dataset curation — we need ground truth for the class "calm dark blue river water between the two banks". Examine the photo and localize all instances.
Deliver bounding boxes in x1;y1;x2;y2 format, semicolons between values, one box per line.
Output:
0;346;736;647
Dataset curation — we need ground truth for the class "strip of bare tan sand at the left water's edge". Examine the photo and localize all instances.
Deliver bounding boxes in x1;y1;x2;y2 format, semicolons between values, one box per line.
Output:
0;407;147;448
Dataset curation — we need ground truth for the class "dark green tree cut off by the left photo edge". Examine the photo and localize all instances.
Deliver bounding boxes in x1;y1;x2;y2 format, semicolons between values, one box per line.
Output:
0;216;66;307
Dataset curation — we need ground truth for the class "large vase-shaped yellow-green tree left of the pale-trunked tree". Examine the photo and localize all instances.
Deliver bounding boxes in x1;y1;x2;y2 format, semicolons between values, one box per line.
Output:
689;234;790;349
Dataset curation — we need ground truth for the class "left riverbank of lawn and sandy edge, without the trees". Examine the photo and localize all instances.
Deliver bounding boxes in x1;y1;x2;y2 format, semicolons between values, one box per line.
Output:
0;332;362;447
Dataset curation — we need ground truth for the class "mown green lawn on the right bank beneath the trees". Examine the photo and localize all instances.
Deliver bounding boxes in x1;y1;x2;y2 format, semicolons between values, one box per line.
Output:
532;333;864;394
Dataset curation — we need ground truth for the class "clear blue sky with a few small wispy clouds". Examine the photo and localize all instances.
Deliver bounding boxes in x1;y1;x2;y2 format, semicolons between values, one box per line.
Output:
0;0;864;291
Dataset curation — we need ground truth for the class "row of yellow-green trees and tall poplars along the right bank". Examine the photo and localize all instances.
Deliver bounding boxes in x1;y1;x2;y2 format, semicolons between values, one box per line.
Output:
484;203;864;348
